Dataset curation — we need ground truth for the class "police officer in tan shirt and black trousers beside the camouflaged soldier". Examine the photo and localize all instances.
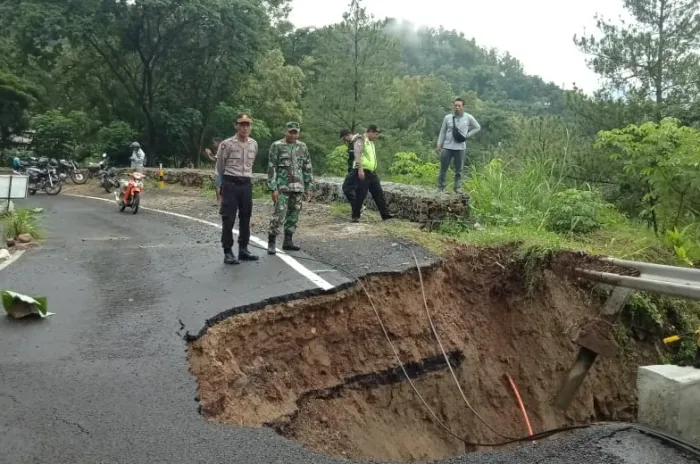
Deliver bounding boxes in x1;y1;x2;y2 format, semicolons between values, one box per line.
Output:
215;113;259;264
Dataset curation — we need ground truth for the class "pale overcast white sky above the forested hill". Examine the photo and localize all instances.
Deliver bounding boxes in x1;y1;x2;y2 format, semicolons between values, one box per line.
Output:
290;0;623;93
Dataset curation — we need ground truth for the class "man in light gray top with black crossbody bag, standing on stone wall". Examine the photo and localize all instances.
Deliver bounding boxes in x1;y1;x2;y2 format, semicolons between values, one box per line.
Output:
437;98;481;193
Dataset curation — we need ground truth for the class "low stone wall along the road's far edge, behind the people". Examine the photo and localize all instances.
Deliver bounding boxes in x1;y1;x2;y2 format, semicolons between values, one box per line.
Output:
118;168;470;224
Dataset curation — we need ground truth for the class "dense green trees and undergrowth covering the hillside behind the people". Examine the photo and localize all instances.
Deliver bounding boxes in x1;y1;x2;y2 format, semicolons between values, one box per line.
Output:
0;0;700;358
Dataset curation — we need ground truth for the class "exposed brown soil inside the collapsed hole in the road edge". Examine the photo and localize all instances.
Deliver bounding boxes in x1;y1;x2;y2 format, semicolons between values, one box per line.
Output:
189;247;656;461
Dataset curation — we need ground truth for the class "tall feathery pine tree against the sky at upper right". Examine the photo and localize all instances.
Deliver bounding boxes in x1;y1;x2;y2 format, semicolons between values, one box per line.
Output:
574;0;700;122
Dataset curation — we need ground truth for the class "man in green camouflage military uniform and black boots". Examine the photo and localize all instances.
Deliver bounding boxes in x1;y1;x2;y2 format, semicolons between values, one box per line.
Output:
267;122;313;255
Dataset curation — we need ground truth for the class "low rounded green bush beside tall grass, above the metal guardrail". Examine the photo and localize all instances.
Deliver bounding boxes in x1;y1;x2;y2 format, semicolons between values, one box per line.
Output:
547;189;605;234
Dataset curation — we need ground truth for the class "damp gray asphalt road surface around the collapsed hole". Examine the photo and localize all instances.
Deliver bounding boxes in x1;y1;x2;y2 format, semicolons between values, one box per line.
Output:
0;195;696;464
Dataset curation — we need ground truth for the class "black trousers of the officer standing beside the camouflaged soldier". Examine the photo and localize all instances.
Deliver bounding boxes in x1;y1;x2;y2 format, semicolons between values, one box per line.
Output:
219;176;253;252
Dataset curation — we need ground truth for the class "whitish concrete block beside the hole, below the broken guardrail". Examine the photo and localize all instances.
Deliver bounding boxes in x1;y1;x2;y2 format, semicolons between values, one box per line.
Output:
637;365;700;445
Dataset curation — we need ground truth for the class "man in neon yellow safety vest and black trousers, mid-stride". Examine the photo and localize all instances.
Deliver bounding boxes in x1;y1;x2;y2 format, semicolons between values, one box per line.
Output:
352;124;393;222
